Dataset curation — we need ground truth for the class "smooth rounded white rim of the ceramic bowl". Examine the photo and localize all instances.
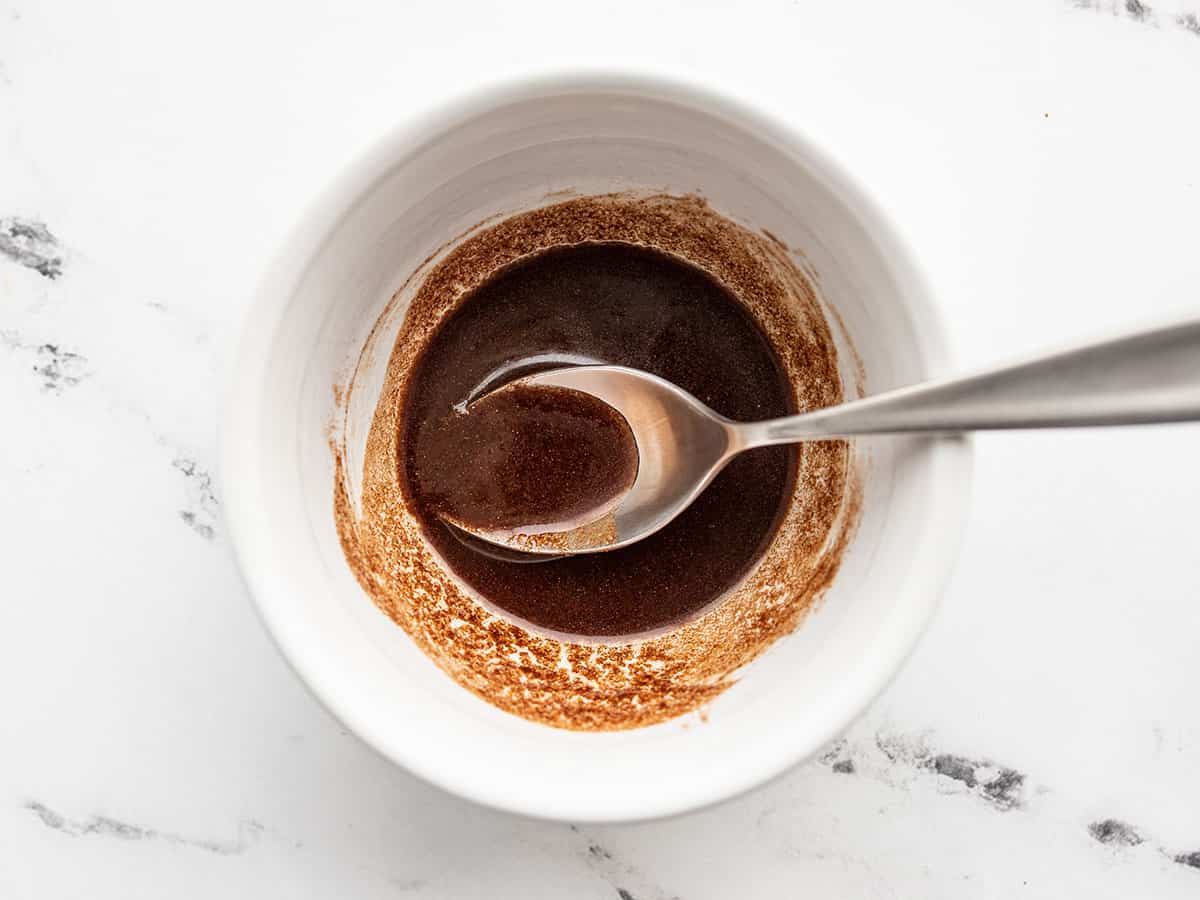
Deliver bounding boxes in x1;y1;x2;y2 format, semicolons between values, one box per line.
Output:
218;67;972;823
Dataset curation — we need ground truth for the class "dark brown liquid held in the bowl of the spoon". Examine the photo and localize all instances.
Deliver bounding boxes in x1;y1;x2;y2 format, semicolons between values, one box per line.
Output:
410;384;637;532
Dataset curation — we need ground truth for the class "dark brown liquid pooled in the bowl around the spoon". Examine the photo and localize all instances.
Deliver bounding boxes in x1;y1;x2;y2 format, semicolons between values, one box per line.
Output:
400;244;796;636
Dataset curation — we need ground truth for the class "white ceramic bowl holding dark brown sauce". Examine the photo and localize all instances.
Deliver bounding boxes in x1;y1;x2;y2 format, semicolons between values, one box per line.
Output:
221;76;970;821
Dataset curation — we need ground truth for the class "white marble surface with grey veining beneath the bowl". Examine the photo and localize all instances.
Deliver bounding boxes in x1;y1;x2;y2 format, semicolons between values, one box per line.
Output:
0;0;1200;900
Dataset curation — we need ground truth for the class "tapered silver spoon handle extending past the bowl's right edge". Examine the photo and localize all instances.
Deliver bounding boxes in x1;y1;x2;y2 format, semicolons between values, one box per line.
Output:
737;320;1200;449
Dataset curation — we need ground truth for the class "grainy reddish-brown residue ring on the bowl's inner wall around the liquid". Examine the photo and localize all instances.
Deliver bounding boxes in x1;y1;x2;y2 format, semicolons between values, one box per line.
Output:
334;194;860;731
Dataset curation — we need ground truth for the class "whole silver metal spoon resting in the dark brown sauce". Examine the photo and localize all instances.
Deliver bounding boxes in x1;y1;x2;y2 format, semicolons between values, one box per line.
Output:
456;322;1200;562
